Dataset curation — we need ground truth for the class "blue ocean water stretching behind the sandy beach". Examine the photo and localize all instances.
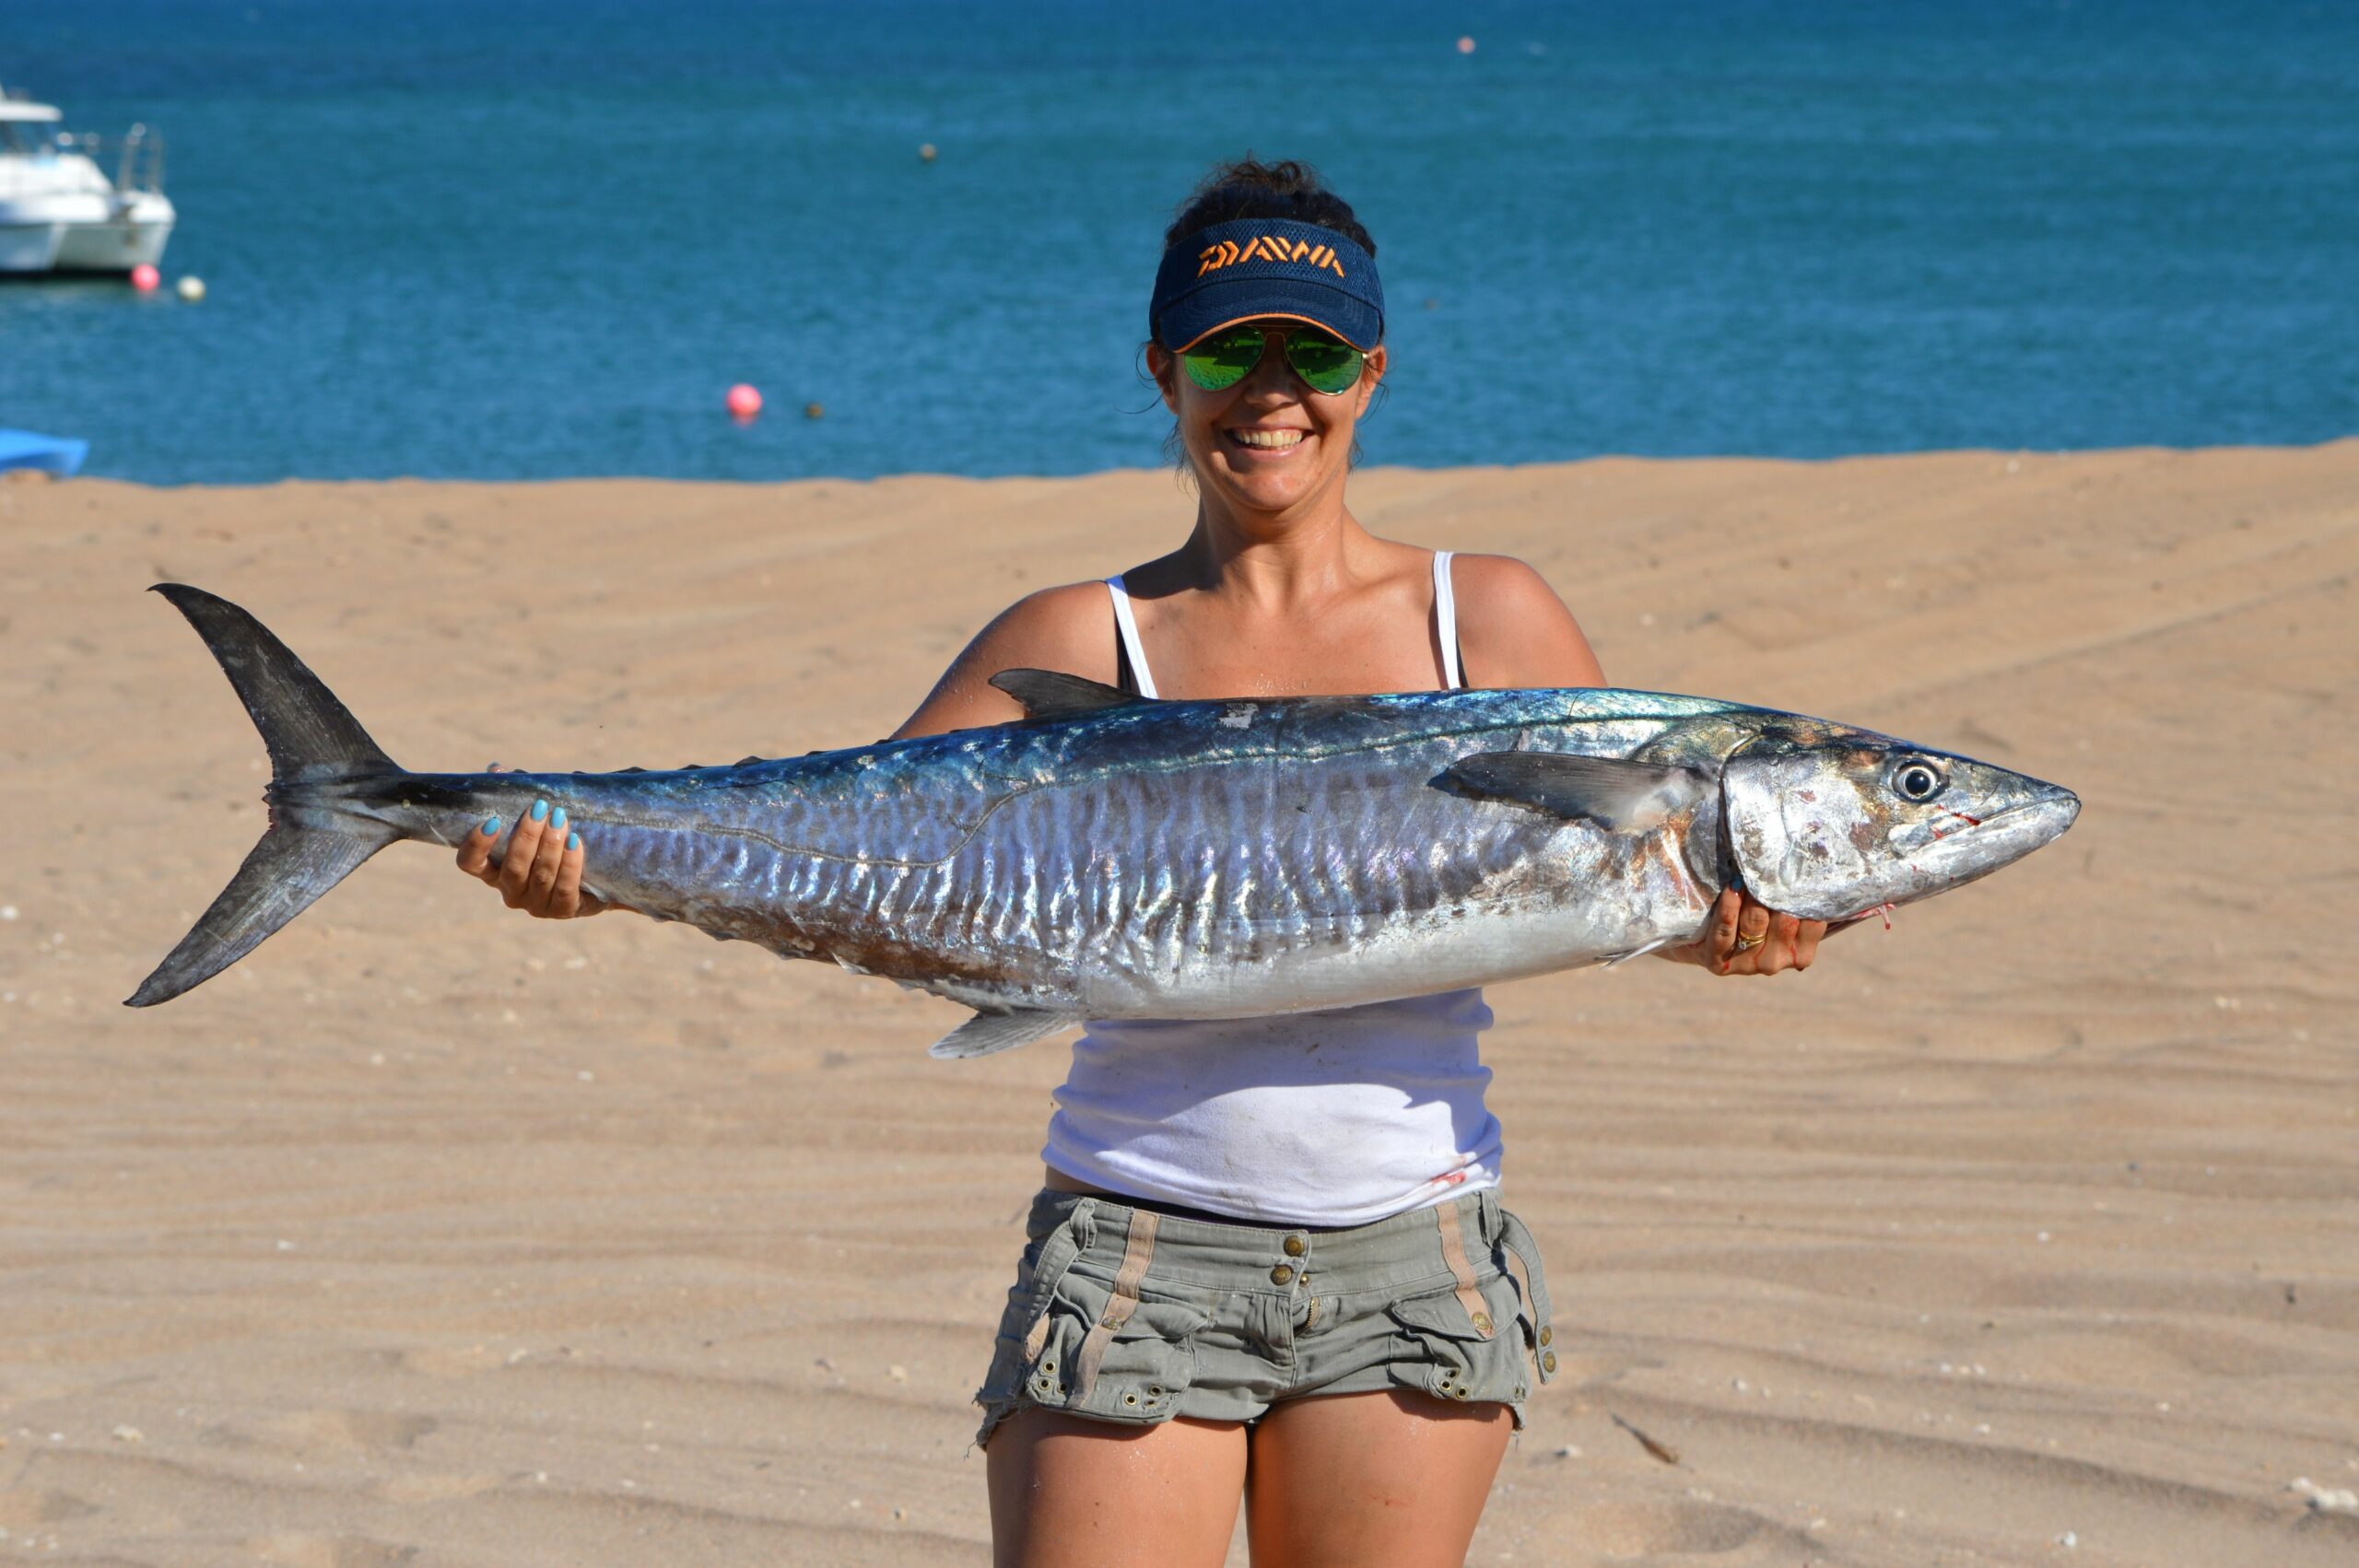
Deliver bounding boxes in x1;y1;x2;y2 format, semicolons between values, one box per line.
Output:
0;0;2359;484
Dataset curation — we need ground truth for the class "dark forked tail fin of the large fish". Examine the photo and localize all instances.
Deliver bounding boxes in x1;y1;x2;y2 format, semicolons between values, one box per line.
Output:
125;582;401;1007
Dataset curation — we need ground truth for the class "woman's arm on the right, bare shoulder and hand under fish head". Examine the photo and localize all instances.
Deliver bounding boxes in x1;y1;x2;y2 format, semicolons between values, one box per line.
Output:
1450;556;1825;974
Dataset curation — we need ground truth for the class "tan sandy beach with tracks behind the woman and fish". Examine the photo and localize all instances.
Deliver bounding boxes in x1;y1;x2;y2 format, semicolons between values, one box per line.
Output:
0;441;2359;1568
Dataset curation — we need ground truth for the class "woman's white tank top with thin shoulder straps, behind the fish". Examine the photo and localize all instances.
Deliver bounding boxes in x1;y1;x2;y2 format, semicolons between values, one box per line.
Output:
1040;552;1500;1226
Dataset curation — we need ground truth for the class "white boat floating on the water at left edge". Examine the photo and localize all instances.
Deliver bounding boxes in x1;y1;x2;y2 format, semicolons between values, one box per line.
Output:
0;94;172;274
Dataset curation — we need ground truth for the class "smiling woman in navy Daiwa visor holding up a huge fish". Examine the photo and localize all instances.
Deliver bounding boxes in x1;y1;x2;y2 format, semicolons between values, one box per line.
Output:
460;160;1824;1568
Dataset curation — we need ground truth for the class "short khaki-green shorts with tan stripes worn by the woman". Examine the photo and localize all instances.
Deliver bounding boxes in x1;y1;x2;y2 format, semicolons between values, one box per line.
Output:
974;1188;1557;1443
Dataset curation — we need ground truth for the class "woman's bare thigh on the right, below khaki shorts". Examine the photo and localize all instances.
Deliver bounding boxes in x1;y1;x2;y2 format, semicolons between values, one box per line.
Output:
1246;1388;1515;1568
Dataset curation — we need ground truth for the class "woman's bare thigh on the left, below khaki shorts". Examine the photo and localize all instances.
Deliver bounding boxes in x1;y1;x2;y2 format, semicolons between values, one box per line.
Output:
984;1410;1246;1568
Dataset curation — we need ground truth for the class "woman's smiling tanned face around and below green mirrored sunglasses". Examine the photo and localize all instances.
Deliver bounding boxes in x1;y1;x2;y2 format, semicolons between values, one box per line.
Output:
1146;321;1385;511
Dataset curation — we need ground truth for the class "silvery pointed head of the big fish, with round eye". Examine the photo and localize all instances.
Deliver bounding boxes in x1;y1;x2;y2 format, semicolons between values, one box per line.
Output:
1719;731;2081;919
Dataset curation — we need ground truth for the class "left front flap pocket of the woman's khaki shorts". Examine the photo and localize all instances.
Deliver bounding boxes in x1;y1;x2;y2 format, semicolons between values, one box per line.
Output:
1021;1269;1213;1424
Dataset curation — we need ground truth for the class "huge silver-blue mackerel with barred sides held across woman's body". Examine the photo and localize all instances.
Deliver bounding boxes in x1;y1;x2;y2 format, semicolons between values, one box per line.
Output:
130;585;2081;1057
